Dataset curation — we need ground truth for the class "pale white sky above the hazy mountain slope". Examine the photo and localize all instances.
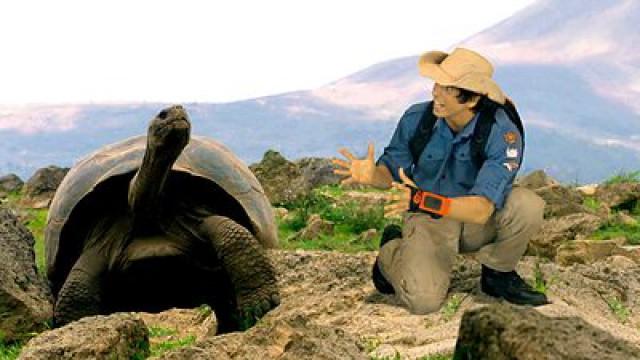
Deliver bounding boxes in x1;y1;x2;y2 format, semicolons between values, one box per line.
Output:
0;0;534;104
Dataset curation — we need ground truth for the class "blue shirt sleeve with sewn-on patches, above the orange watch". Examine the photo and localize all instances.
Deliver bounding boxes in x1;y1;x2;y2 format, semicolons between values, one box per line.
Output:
469;115;523;209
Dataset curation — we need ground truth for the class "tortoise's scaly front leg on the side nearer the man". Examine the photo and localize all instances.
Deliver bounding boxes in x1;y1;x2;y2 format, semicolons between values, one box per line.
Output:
200;216;280;333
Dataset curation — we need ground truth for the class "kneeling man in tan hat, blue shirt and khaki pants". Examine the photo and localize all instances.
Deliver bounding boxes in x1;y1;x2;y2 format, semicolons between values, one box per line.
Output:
334;48;548;314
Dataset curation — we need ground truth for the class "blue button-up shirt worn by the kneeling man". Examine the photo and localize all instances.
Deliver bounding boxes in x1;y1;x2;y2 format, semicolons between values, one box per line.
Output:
378;103;522;209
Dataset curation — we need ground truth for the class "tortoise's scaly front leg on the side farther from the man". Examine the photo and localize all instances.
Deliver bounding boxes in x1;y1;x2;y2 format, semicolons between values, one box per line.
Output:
53;250;107;327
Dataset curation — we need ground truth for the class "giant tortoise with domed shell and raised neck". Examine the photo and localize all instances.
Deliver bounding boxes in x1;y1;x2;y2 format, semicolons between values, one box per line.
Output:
45;106;279;333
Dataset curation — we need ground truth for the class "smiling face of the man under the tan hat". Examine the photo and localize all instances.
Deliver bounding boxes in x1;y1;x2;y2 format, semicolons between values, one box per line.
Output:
431;83;478;132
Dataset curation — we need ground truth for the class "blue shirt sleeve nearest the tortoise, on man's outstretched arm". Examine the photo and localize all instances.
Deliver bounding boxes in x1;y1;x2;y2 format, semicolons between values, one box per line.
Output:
376;107;420;181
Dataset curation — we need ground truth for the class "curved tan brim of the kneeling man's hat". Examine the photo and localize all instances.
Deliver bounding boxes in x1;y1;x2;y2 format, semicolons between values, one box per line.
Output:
418;51;506;104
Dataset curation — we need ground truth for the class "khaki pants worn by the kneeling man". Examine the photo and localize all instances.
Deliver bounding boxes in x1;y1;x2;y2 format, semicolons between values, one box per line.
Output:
378;187;544;314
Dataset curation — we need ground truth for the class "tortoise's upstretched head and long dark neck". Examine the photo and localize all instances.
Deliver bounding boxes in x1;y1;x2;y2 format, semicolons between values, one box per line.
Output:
128;105;191;218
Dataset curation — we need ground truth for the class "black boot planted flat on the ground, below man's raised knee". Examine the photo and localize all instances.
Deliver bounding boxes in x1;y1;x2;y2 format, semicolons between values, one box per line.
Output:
480;265;549;306
